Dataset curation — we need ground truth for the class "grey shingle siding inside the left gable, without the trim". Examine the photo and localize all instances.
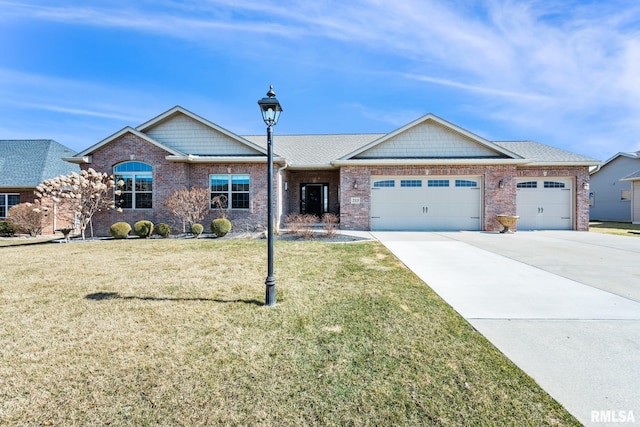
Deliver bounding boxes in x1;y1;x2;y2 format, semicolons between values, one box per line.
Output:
144;114;263;156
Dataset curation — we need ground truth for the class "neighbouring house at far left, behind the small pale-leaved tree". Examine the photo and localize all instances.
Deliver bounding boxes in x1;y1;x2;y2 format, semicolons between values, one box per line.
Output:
0;139;80;234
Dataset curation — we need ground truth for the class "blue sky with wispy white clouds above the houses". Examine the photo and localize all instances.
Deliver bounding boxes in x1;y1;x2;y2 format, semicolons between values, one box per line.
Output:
0;0;640;160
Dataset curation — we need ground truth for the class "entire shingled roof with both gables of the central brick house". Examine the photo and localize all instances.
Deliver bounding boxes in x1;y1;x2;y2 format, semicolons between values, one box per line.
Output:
67;106;600;169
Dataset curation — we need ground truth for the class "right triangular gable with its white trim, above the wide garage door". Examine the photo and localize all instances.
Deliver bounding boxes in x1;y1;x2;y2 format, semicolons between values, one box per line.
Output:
342;114;521;160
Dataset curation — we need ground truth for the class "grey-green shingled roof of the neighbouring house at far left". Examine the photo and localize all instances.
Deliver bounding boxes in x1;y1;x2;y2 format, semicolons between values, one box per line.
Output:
0;139;80;188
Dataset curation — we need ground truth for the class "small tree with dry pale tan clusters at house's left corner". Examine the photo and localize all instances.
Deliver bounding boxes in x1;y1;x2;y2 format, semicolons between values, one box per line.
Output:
35;168;121;240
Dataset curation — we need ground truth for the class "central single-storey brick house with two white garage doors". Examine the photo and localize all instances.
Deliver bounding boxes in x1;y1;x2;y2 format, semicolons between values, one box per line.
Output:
67;106;599;234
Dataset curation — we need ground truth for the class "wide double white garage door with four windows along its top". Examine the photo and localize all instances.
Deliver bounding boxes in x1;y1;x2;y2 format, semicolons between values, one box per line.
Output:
371;176;482;230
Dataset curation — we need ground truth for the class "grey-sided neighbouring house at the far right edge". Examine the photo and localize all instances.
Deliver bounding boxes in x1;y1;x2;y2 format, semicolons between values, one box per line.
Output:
589;151;640;221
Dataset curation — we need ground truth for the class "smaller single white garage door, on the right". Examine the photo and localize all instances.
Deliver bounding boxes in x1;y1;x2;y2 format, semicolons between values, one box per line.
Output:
516;177;573;230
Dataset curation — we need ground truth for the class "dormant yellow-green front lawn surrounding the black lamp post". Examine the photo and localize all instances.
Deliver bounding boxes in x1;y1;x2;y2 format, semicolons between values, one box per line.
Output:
0;239;579;426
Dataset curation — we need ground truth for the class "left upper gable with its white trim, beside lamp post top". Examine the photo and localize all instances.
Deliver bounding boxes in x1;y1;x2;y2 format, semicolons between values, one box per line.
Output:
136;106;266;156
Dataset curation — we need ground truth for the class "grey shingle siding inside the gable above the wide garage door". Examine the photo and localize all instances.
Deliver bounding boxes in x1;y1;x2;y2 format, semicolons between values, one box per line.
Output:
354;122;504;159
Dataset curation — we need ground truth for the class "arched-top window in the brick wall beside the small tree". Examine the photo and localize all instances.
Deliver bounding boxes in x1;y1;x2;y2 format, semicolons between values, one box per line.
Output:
114;162;153;209
